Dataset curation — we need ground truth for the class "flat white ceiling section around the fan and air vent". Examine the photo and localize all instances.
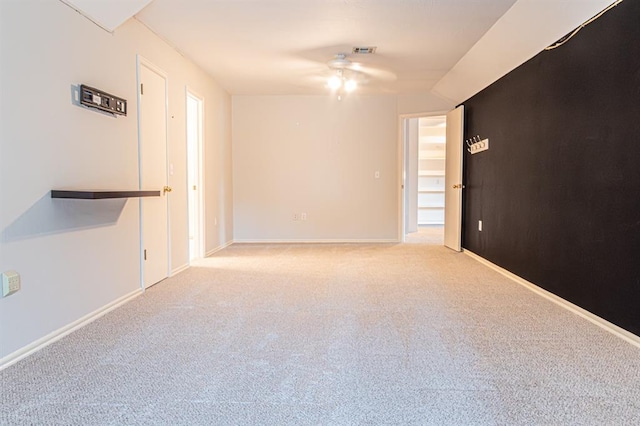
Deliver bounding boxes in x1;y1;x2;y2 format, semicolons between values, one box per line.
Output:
136;0;515;95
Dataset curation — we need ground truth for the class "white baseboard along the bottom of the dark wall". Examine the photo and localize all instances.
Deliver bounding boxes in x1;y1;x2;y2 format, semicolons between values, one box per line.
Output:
464;249;640;348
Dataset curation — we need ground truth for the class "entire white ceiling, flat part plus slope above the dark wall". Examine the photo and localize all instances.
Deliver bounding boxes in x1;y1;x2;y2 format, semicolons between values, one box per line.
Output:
63;0;612;102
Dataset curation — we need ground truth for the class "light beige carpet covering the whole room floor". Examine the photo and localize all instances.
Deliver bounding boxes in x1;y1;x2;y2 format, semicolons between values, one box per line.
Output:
0;228;640;425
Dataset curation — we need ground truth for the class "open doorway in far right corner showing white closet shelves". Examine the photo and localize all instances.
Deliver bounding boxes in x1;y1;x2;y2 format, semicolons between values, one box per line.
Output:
402;114;447;241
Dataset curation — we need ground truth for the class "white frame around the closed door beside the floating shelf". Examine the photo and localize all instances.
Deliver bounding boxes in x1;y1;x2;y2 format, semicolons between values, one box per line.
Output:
136;53;171;290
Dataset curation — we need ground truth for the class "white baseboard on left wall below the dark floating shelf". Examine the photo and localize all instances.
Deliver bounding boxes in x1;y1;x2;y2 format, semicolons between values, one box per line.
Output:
0;289;143;370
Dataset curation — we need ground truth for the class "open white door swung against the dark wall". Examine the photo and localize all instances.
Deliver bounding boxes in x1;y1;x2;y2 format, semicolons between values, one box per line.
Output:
444;105;464;251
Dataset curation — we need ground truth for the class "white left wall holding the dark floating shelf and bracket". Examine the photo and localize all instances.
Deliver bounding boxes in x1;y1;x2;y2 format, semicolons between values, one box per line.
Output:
0;0;233;364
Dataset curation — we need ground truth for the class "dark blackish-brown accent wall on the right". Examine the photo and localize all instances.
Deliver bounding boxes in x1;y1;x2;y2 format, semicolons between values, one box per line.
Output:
463;0;640;335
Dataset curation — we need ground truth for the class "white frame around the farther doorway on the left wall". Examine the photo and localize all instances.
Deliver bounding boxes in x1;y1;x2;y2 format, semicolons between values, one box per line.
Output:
185;85;206;263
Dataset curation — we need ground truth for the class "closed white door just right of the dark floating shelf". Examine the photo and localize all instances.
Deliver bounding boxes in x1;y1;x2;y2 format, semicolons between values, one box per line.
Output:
138;61;170;288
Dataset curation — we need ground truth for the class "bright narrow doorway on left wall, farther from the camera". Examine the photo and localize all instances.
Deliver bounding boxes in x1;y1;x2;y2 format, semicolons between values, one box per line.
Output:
187;88;204;262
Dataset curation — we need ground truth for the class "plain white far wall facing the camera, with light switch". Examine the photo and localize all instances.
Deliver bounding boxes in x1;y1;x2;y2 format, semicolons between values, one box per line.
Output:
233;95;399;241
